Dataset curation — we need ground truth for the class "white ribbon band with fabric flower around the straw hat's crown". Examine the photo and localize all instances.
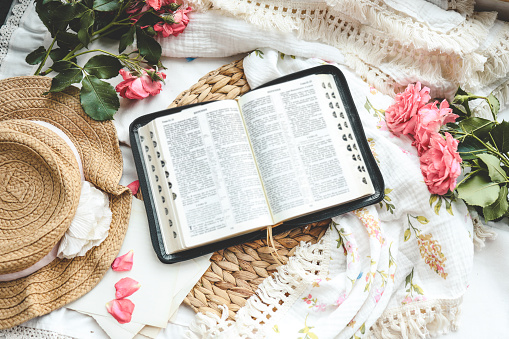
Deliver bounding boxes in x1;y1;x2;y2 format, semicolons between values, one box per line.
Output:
0;121;112;281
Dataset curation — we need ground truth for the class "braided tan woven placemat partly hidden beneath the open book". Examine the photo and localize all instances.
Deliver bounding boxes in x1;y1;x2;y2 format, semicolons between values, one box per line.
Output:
169;60;330;319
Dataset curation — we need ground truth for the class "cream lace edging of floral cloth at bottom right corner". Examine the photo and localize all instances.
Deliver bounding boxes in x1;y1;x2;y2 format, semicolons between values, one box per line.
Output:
367;298;463;339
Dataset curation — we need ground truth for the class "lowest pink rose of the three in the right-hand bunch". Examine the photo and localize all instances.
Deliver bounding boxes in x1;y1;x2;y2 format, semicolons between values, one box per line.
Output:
420;133;461;195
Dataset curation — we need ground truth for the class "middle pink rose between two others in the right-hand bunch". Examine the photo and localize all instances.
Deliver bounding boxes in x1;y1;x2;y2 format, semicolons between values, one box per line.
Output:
412;100;458;156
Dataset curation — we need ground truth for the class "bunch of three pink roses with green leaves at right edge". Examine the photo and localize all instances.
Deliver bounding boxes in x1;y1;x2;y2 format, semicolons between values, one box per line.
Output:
385;83;509;221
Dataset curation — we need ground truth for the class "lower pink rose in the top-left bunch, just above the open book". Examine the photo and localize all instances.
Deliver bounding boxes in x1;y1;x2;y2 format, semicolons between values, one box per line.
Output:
115;69;166;99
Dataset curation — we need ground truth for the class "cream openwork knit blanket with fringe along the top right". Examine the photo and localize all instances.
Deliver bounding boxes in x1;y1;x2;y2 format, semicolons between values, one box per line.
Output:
160;0;509;119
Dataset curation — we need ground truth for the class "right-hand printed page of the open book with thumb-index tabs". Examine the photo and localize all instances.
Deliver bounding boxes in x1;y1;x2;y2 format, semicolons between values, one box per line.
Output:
239;74;374;223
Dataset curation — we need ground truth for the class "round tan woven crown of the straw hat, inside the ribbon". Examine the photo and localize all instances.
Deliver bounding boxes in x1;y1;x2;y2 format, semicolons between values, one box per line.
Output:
0;120;81;274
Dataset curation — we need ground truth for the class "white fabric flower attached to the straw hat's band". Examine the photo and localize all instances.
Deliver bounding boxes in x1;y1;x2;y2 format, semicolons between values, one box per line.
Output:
58;181;112;259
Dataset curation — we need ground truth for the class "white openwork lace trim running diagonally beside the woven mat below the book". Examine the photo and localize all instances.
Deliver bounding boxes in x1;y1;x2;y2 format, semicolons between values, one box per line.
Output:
187;229;332;339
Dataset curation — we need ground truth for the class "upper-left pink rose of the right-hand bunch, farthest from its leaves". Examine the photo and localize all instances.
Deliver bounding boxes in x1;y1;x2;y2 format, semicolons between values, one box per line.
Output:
385;82;431;135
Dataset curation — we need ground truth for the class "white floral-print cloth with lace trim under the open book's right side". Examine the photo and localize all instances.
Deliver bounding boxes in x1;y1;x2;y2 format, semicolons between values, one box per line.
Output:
189;49;473;338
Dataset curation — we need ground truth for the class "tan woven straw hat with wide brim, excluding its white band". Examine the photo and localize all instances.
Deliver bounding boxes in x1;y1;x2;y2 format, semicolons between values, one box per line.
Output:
0;76;132;328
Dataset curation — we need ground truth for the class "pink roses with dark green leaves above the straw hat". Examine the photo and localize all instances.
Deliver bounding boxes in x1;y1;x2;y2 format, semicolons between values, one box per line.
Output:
26;0;191;120
